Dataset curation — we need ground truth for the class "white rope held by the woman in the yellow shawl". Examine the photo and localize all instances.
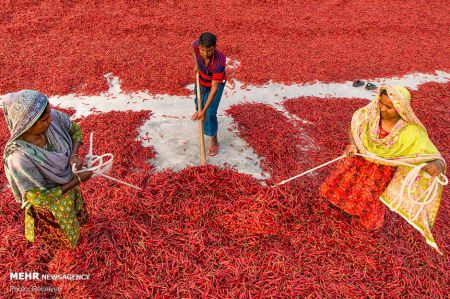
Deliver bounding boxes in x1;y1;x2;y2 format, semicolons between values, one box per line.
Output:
272;153;448;221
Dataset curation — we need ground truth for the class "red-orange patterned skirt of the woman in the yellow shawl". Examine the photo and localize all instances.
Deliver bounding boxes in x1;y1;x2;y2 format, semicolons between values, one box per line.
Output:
320;157;396;229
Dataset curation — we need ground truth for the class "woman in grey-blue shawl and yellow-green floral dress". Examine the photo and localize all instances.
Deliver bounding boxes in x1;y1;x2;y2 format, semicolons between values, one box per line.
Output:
3;90;92;249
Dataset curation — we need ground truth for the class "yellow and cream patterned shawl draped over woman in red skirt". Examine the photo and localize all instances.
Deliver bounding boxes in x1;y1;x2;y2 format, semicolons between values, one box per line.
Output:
351;86;445;251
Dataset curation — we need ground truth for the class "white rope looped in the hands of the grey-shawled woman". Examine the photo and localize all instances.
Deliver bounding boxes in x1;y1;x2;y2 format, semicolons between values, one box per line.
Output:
72;132;142;190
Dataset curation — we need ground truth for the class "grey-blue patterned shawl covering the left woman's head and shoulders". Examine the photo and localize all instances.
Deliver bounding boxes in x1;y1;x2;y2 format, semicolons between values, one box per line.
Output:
3;90;73;202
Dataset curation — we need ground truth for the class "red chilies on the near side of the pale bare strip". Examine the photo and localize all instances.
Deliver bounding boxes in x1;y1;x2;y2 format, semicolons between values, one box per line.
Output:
0;84;450;298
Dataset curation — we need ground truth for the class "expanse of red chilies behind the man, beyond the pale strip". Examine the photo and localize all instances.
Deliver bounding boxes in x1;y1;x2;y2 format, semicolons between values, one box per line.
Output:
0;0;450;95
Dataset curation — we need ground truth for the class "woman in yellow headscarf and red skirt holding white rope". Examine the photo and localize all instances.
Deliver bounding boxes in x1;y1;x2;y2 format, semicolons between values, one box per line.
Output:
320;86;445;249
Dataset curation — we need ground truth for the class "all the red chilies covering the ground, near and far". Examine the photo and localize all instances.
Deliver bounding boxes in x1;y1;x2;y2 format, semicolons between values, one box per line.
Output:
0;0;450;298
